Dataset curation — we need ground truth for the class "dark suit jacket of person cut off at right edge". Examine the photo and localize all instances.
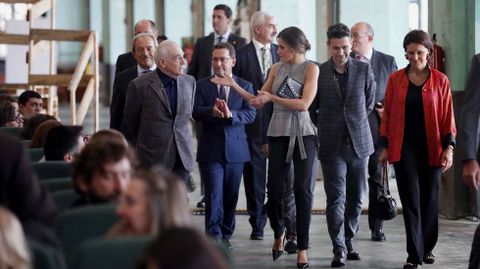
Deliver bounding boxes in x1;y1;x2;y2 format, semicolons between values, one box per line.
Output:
460;54;480;161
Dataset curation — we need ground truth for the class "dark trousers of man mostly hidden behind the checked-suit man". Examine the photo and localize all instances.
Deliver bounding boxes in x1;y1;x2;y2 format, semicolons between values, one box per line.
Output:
368;111;383;231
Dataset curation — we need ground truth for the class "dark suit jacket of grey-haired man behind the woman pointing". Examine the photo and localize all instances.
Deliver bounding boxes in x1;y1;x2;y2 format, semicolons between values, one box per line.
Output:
233;42;280;141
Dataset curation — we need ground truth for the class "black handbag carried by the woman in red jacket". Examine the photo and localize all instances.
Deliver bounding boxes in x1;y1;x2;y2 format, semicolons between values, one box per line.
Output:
375;165;397;220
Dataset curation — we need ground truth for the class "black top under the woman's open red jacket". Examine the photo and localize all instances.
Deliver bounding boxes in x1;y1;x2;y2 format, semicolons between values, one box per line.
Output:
403;81;427;150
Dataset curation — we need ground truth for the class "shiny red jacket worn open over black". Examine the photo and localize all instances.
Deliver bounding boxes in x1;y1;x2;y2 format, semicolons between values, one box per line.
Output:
380;68;457;166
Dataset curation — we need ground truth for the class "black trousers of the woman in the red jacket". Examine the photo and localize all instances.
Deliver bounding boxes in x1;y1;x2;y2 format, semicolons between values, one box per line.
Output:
393;146;442;264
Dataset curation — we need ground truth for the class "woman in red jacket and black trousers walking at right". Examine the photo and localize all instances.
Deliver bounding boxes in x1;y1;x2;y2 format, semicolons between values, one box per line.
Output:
380;30;456;269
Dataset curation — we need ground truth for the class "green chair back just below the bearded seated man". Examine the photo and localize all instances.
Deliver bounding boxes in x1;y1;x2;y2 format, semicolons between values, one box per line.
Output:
56;204;118;261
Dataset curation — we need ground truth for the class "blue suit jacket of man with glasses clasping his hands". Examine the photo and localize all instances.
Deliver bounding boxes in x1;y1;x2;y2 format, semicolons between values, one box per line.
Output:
193;76;256;163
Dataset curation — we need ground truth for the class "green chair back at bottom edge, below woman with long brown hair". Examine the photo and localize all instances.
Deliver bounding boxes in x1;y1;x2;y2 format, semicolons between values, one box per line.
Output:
70;237;153;269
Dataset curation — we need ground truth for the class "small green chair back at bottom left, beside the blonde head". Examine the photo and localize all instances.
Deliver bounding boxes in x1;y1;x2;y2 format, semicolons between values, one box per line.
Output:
28;240;66;269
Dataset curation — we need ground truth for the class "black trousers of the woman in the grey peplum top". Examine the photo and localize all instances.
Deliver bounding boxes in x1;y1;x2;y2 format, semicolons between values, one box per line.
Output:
267;135;317;250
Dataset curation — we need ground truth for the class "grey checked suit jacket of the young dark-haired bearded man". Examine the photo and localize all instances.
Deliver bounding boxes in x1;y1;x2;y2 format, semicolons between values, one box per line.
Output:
313;58;375;160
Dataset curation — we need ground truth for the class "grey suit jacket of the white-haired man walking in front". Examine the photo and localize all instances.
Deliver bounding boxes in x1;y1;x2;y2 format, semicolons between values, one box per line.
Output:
122;68;196;171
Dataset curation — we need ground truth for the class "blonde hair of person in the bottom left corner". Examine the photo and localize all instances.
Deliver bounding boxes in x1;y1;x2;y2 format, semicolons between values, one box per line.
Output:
0;207;31;269
